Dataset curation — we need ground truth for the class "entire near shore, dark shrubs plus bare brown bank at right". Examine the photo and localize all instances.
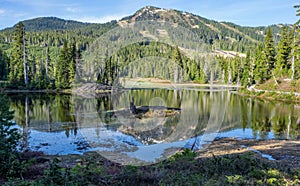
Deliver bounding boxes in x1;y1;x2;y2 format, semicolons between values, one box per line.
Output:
1;138;300;185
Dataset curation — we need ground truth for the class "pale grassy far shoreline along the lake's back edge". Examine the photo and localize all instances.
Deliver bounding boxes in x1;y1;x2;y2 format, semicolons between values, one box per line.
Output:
0;78;300;103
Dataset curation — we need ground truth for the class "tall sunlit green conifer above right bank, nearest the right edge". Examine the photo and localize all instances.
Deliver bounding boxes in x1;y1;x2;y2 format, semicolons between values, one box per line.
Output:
274;27;291;77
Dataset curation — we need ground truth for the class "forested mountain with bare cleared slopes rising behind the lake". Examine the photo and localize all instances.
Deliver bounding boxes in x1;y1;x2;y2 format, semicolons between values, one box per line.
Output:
0;6;296;89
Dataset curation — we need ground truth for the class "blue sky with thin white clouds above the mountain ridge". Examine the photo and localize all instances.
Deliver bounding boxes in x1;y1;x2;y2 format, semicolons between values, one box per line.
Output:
0;0;300;29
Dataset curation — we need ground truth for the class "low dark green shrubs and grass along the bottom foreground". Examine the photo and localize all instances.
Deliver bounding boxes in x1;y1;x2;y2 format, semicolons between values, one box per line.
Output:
5;150;300;185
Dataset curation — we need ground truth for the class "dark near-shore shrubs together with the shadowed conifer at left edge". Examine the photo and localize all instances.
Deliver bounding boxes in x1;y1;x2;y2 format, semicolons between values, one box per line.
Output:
0;96;300;185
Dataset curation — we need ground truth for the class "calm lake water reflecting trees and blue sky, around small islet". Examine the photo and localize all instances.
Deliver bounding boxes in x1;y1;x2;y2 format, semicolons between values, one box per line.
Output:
4;87;300;163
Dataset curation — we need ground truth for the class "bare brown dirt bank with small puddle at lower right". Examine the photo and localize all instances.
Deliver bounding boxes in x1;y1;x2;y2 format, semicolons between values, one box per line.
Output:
197;138;300;168
